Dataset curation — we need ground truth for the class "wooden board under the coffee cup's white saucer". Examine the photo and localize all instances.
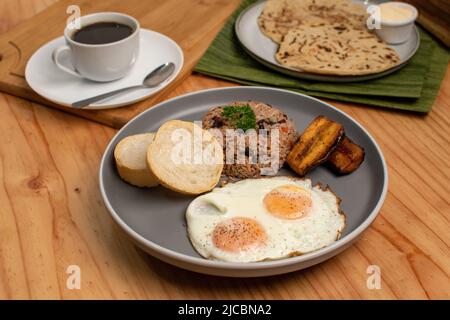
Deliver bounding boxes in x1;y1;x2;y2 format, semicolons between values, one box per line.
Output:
0;0;239;128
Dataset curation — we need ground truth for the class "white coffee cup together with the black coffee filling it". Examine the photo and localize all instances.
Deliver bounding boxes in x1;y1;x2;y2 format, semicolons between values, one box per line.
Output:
53;12;140;82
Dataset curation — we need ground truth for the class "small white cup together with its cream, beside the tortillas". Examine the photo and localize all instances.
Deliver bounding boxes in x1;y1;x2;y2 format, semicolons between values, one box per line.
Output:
376;1;418;44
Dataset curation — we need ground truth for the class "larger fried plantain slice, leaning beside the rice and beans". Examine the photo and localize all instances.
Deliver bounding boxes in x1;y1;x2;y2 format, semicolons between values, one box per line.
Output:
287;116;344;176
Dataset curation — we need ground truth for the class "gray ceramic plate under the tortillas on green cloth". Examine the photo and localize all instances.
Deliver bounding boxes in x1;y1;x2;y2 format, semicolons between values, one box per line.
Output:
235;0;420;82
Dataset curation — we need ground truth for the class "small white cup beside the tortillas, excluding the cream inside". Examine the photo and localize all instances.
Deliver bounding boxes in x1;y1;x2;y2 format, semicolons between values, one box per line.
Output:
376;1;418;44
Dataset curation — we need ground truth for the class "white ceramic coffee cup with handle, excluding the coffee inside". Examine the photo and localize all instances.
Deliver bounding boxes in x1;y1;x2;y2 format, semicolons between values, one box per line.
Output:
53;12;140;82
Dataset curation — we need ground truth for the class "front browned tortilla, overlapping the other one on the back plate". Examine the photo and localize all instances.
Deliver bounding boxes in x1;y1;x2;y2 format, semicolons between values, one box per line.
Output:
275;24;400;75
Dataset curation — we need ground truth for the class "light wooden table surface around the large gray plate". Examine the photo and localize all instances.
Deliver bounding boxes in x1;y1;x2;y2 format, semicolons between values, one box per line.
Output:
0;0;450;299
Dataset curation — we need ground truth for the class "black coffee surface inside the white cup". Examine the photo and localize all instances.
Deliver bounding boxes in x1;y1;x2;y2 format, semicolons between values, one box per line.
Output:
72;22;134;44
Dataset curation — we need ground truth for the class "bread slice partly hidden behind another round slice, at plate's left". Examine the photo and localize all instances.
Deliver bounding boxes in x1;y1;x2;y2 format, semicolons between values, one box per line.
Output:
114;133;159;187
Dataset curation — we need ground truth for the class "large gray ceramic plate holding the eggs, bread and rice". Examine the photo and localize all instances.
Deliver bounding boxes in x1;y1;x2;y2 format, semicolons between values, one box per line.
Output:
100;87;387;277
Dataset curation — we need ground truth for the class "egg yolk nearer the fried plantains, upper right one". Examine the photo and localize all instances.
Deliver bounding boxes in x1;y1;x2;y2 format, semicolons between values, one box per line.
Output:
264;185;312;219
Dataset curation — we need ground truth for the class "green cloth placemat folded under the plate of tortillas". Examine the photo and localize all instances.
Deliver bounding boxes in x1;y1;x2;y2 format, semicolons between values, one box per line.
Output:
195;0;449;112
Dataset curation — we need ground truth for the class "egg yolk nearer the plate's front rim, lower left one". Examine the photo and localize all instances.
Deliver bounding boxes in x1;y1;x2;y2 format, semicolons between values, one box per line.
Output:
213;217;267;252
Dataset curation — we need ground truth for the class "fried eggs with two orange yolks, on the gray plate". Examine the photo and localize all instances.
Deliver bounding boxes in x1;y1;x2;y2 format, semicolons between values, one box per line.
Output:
186;177;345;262
